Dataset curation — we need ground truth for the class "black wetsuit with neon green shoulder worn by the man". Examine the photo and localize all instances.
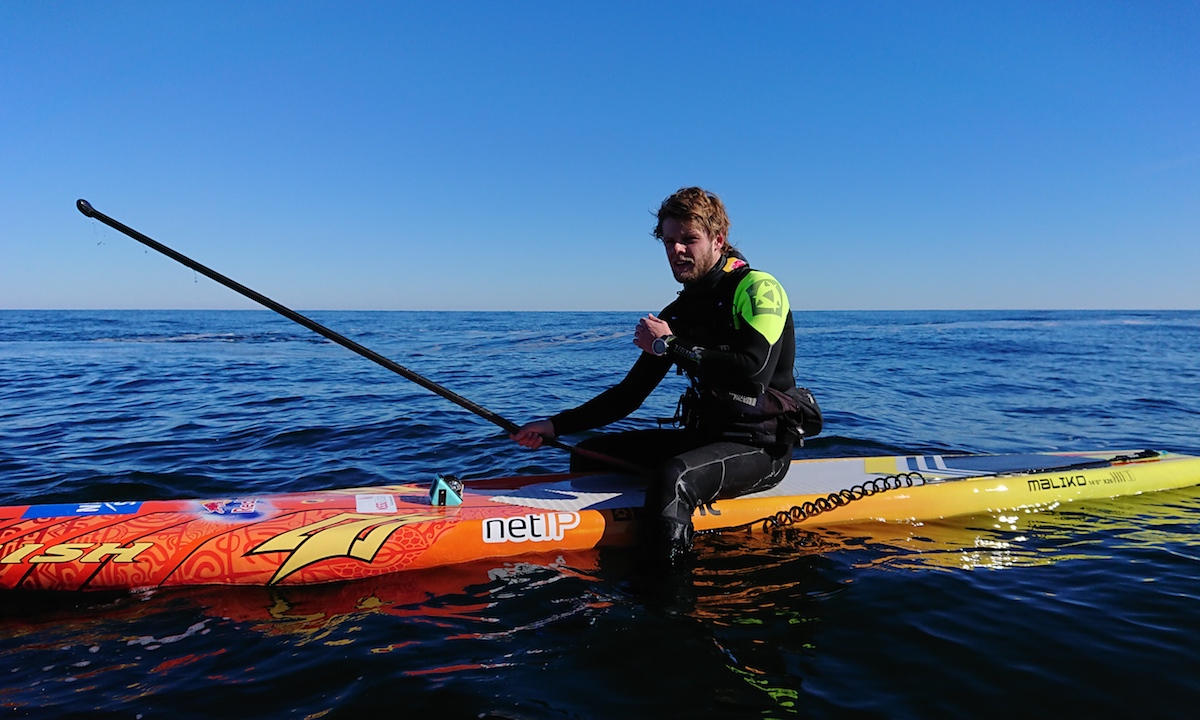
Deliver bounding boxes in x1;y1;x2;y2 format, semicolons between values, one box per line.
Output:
551;253;796;550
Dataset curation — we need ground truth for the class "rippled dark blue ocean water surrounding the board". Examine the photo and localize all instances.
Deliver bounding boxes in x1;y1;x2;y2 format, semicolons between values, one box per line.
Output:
0;311;1200;719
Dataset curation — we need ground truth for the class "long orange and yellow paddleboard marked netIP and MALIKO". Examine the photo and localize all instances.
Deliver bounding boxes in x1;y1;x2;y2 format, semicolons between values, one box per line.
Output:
0;451;1200;590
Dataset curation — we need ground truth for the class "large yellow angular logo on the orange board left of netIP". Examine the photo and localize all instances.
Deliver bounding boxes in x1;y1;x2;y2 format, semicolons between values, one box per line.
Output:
246;512;445;584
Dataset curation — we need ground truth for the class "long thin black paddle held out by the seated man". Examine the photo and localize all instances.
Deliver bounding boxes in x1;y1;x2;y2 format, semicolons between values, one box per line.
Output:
76;199;646;475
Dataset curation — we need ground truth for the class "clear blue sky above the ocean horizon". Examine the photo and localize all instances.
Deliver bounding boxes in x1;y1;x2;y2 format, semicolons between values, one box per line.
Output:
0;0;1200;311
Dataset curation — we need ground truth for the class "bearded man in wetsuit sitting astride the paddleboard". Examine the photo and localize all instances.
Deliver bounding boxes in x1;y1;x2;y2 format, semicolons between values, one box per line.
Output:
512;187;811;559
